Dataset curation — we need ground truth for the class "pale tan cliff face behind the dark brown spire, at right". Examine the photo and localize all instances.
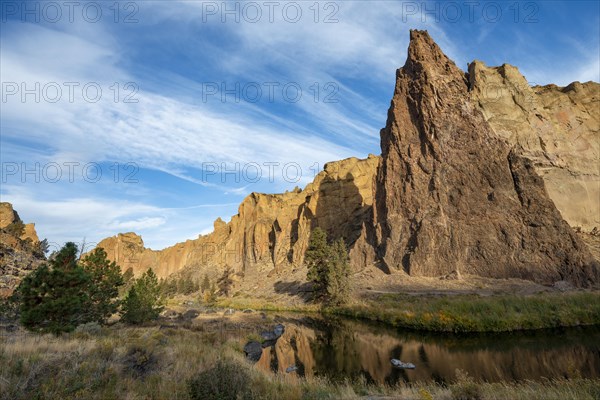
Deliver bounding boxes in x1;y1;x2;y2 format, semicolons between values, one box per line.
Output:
469;61;600;232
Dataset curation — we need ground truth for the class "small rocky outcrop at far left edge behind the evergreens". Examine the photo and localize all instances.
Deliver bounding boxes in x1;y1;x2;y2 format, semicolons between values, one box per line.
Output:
0;202;45;297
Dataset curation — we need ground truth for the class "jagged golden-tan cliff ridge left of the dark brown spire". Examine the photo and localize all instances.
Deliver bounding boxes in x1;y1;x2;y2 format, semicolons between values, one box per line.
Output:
98;156;380;279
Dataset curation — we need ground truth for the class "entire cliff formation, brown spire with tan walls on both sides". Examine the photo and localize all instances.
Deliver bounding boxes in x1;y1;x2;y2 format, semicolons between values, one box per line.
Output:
99;31;600;287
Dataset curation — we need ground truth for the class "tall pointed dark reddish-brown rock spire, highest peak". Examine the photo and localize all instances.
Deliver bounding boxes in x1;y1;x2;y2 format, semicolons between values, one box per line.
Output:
374;31;598;286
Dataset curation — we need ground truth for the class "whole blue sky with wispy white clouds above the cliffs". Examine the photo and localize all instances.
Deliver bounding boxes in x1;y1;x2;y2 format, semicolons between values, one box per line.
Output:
0;1;600;249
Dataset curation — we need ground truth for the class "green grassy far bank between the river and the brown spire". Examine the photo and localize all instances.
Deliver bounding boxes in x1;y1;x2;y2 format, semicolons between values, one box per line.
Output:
220;292;600;332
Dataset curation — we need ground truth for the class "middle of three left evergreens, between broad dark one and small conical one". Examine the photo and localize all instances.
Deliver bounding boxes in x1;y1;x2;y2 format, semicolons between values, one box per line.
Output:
80;247;124;324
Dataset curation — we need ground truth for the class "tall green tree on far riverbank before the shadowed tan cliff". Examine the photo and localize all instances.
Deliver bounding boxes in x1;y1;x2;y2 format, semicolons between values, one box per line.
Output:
304;228;350;305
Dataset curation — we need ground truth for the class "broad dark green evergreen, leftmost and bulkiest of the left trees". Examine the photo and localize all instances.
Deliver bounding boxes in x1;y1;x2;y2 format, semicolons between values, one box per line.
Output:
17;242;92;334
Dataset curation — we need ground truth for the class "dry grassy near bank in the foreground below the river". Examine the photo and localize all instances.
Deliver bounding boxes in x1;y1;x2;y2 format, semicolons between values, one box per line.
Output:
0;325;600;400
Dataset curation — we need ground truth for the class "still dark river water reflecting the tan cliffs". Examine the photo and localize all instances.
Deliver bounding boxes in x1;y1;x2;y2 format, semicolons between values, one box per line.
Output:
257;318;600;384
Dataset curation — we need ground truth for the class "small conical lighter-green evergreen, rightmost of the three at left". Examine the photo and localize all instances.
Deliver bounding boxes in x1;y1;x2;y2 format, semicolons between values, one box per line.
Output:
121;268;164;324
